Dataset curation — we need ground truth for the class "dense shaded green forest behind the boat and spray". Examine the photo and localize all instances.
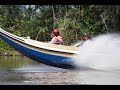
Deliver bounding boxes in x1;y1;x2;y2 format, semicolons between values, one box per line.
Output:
0;5;120;51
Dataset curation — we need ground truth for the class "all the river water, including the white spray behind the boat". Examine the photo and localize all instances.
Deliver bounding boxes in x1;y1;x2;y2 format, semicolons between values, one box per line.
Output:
0;34;120;85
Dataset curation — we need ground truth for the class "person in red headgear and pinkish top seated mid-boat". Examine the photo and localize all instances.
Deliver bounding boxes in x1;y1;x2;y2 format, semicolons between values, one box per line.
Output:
49;27;63;45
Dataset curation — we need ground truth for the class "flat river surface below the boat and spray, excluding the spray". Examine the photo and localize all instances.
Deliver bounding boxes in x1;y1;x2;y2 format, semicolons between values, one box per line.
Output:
0;56;120;85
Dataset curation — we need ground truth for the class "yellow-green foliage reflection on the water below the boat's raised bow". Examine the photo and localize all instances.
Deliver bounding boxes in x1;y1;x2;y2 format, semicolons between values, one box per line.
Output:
0;56;37;70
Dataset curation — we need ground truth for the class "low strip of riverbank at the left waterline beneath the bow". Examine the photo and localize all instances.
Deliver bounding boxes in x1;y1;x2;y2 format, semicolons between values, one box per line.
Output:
0;51;22;56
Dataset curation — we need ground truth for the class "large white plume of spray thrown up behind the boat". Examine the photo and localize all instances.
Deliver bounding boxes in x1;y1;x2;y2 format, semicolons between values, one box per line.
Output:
75;33;120;70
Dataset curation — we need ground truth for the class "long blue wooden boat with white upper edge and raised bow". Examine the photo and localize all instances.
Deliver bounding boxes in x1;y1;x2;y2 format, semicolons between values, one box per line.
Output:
0;28;79;69
